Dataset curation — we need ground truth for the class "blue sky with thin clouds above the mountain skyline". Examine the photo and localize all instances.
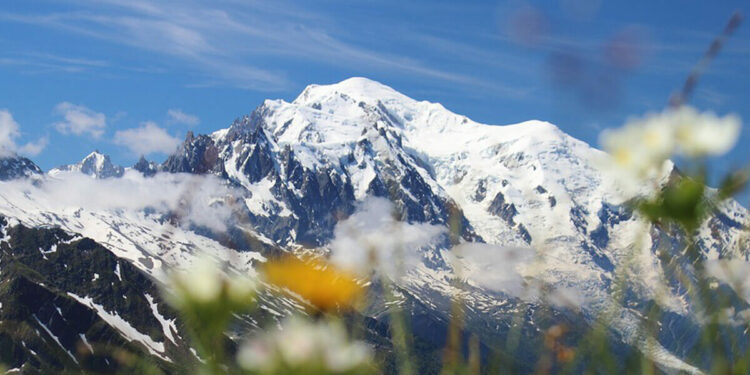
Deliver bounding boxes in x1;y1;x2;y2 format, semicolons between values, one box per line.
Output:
0;0;750;185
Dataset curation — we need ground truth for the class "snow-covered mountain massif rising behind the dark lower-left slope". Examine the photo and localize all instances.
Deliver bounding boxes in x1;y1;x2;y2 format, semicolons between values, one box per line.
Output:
0;78;747;373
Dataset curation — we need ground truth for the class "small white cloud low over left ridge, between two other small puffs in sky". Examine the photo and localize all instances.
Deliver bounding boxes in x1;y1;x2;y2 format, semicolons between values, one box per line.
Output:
114;121;180;155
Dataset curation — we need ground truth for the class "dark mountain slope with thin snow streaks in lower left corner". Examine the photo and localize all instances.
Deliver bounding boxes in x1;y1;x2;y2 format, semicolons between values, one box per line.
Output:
0;217;192;373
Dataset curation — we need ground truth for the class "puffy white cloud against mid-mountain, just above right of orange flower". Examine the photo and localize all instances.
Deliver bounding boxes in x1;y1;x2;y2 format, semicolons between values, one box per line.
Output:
329;198;446;277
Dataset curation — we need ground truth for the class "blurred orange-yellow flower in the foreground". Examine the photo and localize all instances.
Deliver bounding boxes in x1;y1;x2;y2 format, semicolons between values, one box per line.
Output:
264;256;364;311
